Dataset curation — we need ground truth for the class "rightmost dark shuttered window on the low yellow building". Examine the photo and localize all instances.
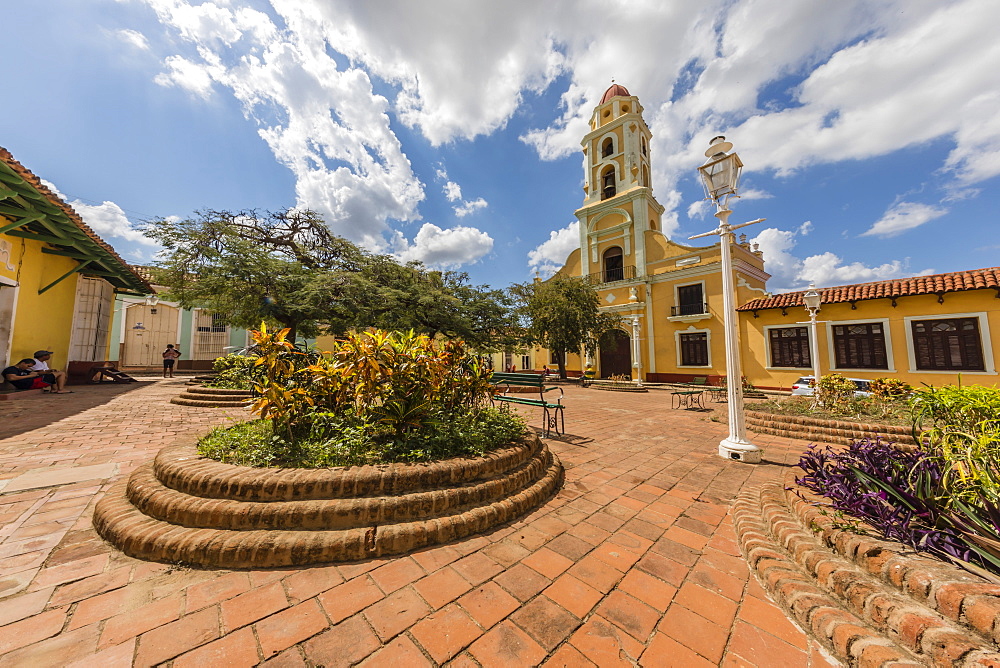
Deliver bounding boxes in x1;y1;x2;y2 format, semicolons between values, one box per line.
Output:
910;318;986;371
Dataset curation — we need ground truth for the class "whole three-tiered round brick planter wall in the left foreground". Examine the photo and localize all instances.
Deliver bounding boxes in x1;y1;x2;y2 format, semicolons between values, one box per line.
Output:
94;433;563;568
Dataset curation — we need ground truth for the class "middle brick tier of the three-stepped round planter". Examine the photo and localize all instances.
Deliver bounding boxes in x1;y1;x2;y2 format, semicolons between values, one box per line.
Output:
126;449;552;531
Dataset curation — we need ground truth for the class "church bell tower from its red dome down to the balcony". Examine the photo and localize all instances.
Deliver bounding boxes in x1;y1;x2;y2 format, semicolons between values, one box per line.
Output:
576;83;664;282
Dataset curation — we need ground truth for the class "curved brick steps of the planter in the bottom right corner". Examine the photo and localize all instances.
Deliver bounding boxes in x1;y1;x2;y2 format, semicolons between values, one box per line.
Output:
733;484;1000;666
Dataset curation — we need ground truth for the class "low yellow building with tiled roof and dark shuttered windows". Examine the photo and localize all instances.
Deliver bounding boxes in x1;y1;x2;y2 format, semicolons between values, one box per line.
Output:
738;267;1000;389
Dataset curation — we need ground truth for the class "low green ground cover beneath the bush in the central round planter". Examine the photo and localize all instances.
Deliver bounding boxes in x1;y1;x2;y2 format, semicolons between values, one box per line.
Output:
198;407;526;468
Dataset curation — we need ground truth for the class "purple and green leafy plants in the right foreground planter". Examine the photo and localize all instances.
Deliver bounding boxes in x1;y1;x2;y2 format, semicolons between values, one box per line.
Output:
797;386;1000;573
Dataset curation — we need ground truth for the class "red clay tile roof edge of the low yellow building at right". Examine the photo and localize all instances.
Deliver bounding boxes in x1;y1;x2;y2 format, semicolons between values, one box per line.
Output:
736;267;1000;311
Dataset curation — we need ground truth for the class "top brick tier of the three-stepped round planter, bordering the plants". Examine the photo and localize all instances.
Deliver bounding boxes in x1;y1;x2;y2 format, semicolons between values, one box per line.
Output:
153;433;543;501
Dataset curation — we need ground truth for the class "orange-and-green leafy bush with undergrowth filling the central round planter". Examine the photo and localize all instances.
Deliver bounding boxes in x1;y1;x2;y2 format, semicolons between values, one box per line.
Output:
199;326;525;467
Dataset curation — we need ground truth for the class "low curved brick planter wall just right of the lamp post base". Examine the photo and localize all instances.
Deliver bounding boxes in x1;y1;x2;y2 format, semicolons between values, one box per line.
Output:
746;411;916;447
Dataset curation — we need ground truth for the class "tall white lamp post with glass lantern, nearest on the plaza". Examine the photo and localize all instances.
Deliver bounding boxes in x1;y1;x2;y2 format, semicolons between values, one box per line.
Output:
689;136;764;464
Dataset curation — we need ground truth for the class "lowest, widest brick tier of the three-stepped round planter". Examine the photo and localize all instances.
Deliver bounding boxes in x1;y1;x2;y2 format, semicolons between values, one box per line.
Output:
94;456;563;568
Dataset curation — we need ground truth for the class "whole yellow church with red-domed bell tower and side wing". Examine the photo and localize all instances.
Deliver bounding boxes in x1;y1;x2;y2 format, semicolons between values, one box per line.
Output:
560;83;769;382
